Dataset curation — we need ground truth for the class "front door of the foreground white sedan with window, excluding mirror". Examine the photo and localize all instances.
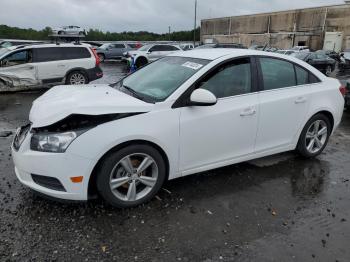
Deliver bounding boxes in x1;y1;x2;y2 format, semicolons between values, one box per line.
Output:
180;58;258;175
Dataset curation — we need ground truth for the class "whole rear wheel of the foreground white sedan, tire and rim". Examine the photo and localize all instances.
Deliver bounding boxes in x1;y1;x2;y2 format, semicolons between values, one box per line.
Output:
297;114;332;158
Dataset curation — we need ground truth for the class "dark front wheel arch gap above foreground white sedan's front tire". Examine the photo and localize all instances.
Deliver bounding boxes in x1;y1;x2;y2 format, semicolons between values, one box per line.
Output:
87;139;170;198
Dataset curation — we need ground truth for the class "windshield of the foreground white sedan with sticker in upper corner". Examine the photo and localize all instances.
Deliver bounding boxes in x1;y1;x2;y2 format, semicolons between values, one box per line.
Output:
112;57;210;103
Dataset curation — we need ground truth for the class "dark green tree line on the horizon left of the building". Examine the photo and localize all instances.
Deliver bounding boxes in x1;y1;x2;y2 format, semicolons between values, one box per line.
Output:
0;25;200;41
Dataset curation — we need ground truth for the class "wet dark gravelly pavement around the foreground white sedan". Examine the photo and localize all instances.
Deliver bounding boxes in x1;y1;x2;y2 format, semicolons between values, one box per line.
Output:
0;63;350;261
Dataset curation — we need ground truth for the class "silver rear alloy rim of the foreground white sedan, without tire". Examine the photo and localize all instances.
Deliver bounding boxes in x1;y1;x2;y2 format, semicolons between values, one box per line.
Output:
305;120;328;154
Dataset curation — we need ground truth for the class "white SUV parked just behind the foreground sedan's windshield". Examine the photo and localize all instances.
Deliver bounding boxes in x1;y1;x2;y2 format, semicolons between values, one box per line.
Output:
125;44;183;68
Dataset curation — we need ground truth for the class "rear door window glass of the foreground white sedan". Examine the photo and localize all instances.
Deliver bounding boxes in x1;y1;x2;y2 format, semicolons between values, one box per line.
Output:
260;57;296;90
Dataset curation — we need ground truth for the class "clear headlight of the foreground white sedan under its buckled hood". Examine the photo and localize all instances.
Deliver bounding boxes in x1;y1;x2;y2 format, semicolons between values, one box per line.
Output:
30;131;83;153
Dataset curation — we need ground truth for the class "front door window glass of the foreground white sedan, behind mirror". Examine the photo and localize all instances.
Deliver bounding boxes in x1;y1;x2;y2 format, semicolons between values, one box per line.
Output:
198;58;252;98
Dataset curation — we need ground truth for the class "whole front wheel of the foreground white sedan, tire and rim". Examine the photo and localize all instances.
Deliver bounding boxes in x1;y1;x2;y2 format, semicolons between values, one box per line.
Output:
96;145;166;208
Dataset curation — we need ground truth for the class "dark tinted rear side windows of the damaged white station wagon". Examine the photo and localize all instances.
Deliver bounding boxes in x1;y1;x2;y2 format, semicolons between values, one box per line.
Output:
34;47;91;62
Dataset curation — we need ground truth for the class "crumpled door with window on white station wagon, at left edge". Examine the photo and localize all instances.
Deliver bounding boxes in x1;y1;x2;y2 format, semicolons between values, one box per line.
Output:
0;49;39;86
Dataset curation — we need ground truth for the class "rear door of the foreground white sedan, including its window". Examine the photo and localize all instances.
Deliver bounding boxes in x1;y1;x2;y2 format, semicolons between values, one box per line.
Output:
256;57;312;153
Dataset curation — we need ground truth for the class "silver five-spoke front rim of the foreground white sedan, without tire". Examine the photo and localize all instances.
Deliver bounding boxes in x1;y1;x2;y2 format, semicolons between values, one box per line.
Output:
109;153;158;202
